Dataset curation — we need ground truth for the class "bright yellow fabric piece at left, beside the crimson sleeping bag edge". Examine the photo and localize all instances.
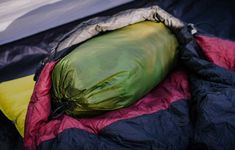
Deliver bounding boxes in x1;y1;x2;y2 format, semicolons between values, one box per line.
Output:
0;75;35;137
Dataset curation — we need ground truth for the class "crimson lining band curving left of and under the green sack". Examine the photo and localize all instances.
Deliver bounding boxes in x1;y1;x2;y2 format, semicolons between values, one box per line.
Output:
24;62;191;149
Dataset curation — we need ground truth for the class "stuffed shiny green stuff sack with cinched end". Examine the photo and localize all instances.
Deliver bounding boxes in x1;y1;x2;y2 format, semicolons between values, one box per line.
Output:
52;21;178;116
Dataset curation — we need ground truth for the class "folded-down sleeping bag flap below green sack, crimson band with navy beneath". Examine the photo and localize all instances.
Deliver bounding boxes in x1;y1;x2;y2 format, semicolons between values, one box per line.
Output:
24;59;192;149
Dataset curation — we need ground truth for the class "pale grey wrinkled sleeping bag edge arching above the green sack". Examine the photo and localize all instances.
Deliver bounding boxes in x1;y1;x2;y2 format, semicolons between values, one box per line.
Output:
55;5;184;51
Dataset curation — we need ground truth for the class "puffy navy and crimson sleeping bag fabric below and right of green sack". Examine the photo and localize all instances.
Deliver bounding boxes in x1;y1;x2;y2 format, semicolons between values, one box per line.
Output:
25;3;235;150
